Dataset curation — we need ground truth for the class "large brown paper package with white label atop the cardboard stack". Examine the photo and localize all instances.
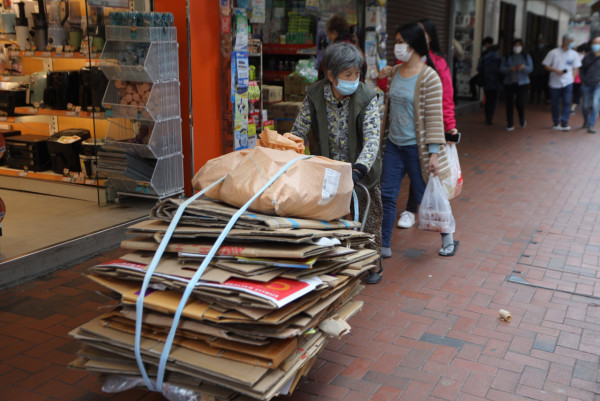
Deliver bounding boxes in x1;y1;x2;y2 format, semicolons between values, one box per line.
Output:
192;146;353;220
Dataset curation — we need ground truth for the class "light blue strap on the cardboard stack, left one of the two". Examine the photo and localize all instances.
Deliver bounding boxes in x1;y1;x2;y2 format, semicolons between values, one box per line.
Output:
134;176;226;391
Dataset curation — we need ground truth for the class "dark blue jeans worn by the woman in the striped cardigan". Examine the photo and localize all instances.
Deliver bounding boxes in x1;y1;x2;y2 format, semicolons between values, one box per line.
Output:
381;140;425;248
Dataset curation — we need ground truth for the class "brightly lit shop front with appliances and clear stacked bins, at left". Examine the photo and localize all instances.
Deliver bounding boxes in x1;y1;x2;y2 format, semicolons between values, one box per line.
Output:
0;0;192;285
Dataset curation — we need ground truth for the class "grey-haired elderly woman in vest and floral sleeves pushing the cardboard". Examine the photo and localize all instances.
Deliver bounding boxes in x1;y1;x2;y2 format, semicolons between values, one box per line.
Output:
292;43;383;284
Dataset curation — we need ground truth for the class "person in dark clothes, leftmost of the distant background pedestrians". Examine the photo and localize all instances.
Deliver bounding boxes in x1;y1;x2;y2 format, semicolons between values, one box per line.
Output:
477;41;502;125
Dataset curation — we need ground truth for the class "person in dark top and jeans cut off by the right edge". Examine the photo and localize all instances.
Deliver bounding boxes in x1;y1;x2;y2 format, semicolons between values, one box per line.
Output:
581;36;600;134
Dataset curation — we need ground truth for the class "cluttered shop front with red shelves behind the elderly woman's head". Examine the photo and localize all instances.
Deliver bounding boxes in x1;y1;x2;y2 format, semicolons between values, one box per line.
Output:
219;0;387;153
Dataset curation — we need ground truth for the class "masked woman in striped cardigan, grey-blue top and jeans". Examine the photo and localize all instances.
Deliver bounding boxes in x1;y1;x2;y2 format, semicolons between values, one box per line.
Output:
381;23;458;258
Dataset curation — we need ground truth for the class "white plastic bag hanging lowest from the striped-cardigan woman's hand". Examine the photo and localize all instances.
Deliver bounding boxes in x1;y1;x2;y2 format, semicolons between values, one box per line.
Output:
419;174;456;233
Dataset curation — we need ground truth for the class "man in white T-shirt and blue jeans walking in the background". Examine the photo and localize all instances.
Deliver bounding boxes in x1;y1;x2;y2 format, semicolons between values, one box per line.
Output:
542;33;581;131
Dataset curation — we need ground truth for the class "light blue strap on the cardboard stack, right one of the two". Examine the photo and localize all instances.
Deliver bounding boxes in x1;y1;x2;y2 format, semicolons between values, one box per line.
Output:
152;155;313;389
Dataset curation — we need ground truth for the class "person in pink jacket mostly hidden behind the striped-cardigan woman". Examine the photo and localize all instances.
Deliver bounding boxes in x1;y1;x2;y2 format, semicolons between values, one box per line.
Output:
377;19;458;228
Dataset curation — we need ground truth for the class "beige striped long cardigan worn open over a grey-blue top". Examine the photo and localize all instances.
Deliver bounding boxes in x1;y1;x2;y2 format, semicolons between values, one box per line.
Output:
382;65;450;187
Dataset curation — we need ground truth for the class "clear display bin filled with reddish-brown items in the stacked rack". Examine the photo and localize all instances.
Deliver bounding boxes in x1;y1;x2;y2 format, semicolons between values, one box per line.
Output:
102;81;181;121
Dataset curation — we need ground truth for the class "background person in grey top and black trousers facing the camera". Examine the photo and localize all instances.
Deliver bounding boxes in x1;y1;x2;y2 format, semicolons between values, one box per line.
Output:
500;39;533;131
